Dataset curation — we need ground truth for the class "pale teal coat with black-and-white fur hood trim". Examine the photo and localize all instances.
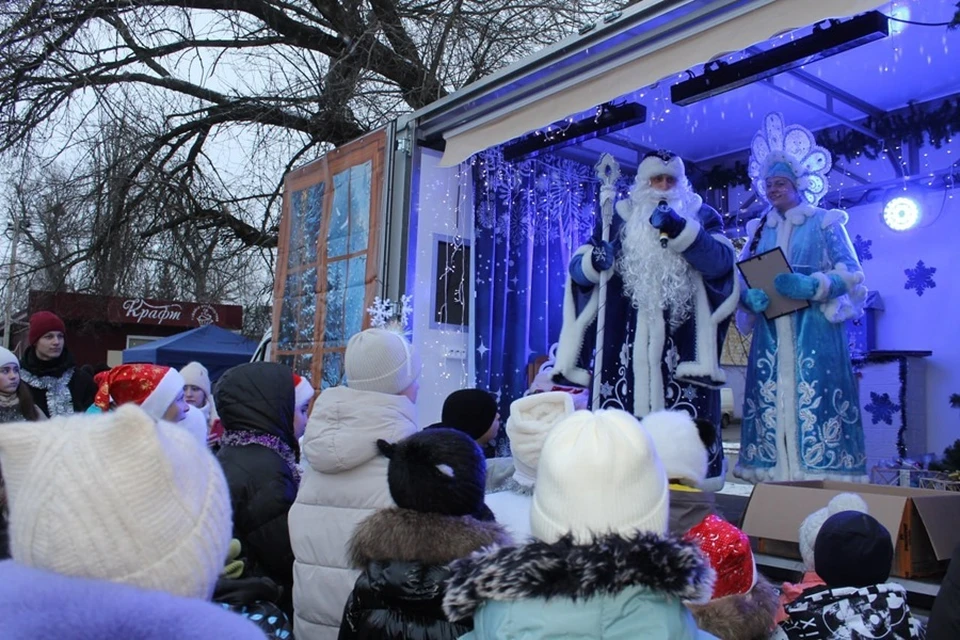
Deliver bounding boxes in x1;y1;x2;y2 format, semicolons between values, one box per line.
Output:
443;534;715;640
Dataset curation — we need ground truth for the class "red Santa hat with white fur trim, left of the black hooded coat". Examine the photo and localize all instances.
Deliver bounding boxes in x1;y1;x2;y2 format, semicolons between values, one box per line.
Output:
93;364;183;420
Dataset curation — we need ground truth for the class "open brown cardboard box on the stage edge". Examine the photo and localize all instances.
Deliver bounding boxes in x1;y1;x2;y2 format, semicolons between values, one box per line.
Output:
741;480;960;578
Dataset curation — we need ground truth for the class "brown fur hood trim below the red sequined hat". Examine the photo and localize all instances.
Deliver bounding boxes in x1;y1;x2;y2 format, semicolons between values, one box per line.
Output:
689;575;780;640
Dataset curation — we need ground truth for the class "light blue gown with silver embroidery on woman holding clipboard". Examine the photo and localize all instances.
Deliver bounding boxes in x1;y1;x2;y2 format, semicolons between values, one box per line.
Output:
734;203;867;482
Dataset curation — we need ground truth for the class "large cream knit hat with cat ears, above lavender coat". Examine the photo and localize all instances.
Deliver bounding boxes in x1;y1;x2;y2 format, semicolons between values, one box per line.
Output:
0;405;232;599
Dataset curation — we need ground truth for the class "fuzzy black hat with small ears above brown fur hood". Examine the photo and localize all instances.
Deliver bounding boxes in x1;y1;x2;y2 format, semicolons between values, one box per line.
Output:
377;428;487;516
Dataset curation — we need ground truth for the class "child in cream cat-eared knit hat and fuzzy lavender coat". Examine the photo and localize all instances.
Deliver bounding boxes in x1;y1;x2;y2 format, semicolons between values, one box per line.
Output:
0;405;262;640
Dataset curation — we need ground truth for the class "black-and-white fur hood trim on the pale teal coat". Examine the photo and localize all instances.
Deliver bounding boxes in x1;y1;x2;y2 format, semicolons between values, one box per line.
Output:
443;533;715;621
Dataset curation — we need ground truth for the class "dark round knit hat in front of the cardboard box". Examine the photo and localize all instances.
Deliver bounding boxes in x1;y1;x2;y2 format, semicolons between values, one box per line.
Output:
813;511;893;587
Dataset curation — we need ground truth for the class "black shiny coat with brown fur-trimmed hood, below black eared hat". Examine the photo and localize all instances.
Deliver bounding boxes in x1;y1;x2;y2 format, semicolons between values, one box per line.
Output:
340;507;510;640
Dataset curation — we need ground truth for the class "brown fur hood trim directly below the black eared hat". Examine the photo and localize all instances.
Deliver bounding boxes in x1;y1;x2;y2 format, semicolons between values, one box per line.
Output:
350;507;512;569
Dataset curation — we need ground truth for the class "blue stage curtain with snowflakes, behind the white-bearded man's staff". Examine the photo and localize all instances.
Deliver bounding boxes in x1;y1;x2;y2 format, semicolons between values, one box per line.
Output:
473;149;616;455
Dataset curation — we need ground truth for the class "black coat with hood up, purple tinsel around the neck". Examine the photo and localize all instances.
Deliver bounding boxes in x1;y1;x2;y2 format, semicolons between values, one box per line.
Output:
214;362;300;616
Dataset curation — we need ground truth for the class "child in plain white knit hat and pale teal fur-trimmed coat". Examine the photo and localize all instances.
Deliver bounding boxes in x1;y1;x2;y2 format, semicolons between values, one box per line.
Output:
444;410;714;640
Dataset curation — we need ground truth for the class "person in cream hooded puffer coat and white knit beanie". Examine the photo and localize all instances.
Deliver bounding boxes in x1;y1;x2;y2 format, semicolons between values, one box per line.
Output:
289;329;421;638
